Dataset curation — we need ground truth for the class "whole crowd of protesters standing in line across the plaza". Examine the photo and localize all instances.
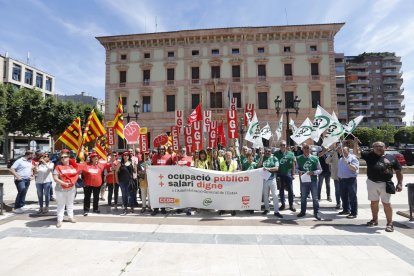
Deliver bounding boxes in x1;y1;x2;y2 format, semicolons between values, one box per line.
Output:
10;138;402;232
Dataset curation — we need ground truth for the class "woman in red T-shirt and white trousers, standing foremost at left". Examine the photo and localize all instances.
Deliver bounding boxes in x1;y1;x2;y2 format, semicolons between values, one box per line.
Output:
53;153;81;228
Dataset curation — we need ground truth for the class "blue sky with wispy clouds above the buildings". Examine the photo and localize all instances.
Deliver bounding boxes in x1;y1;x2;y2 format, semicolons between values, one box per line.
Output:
0;0;414;121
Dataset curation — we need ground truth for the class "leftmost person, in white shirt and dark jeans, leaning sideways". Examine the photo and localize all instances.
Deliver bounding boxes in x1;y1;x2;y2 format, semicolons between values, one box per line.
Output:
9;150;34;214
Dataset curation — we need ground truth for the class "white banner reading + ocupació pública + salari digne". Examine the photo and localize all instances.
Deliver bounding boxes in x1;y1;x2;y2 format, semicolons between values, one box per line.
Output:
147;166;263;210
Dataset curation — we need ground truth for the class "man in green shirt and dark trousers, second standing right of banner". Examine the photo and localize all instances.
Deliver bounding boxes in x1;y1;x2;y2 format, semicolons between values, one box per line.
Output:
273;140;296;212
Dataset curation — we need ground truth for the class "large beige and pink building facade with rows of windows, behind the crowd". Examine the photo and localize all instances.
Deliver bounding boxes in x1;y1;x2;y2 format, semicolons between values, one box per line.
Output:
97;23;344;149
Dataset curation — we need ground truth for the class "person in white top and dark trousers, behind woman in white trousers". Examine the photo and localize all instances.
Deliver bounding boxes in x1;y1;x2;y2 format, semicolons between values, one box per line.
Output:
35;153;55;214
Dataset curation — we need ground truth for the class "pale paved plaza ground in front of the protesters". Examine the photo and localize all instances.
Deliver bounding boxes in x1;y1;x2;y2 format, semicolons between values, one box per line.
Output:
0;175;414;275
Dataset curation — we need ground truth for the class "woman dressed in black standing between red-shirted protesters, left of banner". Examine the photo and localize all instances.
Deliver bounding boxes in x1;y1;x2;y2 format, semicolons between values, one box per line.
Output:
115;151;137;216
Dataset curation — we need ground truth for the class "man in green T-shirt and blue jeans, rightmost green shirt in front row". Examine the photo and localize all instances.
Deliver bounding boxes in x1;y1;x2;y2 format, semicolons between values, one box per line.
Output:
296;143;322;220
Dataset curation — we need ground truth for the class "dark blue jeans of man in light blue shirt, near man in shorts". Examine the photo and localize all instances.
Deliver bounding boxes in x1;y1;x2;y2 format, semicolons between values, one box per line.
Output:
339;177;358;216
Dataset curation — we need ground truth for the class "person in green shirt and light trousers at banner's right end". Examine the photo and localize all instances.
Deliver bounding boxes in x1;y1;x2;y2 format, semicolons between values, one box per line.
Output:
257;148;283;218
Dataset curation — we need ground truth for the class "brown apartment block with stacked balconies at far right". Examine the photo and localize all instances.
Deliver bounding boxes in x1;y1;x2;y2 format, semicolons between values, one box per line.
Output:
345;53;405;127
